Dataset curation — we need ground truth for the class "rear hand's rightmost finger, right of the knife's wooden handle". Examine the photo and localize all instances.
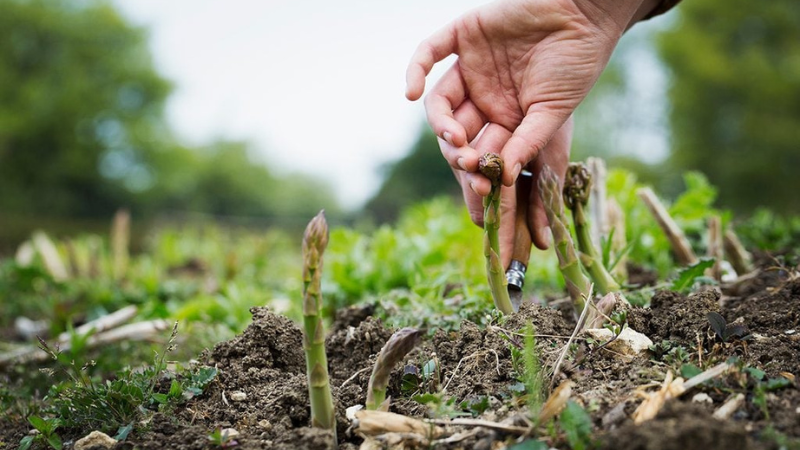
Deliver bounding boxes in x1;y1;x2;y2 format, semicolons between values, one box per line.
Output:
528;117;573;250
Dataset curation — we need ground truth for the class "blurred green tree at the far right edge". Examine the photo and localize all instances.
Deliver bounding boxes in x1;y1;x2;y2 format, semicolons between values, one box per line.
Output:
659;0;800;212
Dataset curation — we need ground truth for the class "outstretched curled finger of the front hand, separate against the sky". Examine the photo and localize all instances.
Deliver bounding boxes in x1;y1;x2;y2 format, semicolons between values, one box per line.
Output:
406;25;456;100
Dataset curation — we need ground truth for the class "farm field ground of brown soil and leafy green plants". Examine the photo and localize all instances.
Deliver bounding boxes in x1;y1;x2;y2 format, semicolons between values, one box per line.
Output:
0;171;800;449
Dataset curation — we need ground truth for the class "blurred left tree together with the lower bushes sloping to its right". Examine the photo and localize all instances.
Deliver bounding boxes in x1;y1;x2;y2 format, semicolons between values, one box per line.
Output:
0;0;338;223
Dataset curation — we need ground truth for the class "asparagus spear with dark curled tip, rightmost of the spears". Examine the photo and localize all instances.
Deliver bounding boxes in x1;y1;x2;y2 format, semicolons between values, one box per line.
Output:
564;163;619;295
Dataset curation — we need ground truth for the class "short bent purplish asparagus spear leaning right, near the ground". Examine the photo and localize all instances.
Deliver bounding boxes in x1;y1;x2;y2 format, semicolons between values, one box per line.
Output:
367;328;422;410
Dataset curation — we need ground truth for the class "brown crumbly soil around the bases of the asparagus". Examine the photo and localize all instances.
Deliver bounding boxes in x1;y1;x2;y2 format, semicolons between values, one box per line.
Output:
0;273;800;450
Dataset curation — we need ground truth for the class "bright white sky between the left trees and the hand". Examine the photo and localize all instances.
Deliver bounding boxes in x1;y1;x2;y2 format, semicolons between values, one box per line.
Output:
115;0;484;207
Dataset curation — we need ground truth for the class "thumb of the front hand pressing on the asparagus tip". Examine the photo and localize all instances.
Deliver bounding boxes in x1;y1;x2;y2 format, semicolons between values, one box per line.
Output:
501;103;569;186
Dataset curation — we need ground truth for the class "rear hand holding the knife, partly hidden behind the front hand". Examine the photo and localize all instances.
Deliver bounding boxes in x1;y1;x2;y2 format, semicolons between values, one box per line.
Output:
446;117;573;267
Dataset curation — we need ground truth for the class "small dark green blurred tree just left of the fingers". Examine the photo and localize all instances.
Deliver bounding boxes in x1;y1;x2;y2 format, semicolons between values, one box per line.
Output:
364;125;461;222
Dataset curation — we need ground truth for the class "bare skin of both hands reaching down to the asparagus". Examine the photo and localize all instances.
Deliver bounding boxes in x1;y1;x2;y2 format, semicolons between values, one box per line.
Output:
406;0;657;267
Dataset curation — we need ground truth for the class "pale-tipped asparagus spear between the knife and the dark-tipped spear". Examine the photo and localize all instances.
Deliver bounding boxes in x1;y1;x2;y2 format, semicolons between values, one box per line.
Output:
539;165;591;313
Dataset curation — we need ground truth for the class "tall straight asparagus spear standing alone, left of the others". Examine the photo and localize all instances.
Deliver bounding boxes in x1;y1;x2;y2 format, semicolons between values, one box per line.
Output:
303;211;336;441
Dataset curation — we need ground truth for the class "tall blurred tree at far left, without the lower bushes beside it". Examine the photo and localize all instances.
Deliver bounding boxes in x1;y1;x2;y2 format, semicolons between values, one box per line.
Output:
0;0;170;216
